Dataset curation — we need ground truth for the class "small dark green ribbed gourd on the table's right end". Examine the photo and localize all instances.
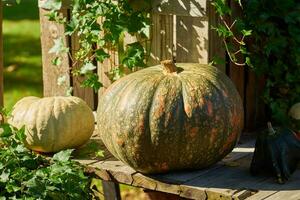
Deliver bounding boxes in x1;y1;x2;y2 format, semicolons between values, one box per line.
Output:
250;123;300;183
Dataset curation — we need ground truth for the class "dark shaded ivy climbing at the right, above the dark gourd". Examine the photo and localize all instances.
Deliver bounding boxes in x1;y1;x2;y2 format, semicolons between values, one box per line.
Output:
213;0;300;123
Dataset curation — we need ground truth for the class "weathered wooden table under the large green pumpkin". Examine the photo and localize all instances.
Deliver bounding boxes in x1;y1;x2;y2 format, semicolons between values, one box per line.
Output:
75;134;300;200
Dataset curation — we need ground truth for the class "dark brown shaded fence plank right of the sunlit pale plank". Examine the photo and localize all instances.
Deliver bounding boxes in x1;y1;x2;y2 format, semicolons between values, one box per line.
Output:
207;5;226;73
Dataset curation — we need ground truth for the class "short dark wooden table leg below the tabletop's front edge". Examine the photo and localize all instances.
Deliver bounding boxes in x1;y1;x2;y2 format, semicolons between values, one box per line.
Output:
102;181;121;200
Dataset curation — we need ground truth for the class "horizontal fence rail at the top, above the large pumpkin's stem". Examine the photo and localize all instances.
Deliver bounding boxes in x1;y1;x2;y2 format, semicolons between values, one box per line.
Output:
152;0;210;17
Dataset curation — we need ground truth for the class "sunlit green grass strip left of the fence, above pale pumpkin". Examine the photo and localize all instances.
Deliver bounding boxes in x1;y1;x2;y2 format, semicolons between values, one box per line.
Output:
3;0;42;109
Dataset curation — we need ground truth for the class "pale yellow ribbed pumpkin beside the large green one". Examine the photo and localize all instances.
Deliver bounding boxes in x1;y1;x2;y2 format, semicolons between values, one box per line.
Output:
8;97;95;152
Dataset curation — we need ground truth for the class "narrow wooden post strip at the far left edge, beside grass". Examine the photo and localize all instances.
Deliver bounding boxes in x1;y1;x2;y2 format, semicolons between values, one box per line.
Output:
0;1;4;107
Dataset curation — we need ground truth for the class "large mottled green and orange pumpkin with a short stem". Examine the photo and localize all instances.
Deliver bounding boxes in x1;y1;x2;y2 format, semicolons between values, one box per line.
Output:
97;61;244;173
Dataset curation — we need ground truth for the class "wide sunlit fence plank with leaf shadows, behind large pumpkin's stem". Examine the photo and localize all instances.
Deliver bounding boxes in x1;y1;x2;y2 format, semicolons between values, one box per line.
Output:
176;16;209;63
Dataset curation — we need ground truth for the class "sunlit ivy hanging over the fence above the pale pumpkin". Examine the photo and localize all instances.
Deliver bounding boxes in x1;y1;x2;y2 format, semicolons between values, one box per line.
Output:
41;0;150;91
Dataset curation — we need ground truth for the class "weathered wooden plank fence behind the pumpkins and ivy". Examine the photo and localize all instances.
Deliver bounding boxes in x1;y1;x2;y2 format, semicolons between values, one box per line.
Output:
40;0;264;130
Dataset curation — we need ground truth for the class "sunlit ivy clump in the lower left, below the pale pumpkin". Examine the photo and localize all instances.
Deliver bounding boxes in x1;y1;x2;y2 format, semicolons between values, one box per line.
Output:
0;119;93;200
